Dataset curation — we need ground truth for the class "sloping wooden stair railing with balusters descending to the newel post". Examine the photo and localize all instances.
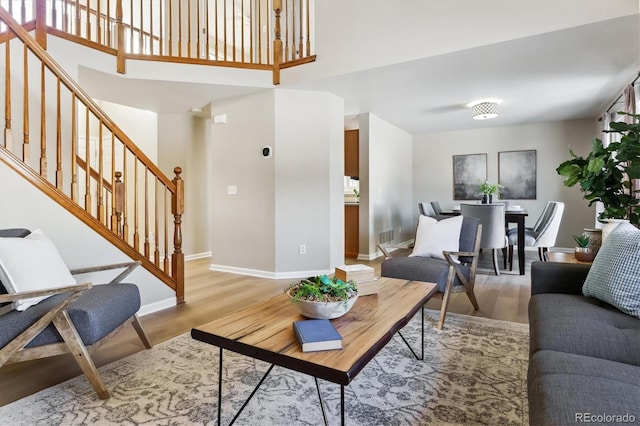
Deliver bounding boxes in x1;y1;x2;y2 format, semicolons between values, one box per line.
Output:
0;7;184;303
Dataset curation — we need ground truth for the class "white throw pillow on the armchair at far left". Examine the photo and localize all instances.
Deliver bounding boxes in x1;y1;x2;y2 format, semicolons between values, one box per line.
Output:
0;229;77;311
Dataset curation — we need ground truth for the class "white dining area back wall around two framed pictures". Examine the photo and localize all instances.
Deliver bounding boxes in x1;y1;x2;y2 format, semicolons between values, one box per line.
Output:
413;120;598;247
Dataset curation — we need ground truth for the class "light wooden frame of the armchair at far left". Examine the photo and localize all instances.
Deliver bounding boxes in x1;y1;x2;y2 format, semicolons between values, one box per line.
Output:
0;262;152;399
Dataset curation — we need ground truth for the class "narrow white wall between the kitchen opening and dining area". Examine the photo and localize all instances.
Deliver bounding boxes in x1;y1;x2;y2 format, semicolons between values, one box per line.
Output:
358;114;415;260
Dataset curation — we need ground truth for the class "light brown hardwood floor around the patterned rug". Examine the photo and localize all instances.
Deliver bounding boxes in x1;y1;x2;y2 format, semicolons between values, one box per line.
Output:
0;252;536;406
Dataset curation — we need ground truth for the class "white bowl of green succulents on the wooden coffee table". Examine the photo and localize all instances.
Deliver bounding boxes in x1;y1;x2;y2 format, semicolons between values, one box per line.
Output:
284;275;358;319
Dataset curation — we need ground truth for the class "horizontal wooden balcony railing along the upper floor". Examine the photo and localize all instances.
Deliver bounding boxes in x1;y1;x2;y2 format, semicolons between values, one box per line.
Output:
0;0;316;84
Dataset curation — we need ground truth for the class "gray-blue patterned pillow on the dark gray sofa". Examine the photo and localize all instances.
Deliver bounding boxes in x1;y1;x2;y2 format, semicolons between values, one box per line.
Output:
582;223;640;318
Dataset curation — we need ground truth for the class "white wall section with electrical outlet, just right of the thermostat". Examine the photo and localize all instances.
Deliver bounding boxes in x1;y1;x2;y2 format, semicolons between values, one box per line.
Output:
274;90;344;276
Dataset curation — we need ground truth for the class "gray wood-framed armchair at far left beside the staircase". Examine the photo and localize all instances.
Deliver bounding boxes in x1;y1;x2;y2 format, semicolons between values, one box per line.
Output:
0;229;151;399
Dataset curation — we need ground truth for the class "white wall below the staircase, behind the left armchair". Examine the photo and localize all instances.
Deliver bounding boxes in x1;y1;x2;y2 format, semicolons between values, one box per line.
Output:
0;162;175;313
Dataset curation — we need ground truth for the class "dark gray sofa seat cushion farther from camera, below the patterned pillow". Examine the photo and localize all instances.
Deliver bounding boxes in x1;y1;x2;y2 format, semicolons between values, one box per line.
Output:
529;294;640;366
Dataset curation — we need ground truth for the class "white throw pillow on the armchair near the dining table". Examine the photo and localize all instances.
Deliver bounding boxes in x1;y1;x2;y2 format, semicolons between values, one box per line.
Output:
409;215;463;259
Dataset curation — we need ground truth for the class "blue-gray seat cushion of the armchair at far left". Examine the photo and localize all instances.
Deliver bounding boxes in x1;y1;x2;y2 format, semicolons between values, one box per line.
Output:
0;283;140;348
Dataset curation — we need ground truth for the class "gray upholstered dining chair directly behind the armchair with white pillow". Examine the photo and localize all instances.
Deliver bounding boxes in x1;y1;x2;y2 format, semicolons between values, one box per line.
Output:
460;204;507;275
